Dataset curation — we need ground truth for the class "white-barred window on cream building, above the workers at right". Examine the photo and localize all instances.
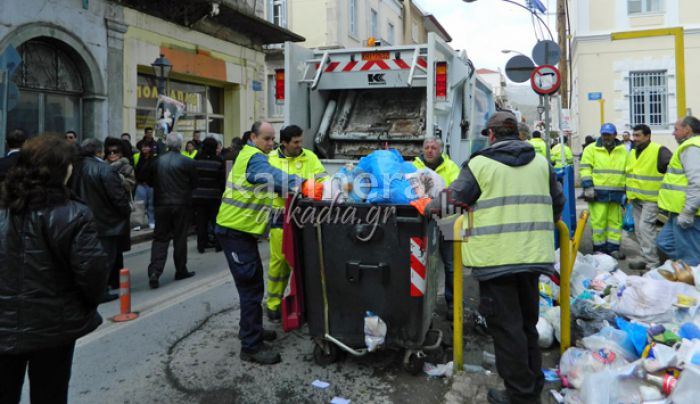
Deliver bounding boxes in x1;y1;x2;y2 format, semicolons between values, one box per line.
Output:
629;70;668;126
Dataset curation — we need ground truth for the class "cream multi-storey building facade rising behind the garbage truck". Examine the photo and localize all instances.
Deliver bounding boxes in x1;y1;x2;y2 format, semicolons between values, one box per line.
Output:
265;0;452;129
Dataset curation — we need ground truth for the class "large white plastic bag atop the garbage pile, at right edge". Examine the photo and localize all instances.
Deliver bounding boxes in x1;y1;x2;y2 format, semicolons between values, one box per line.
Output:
612;276;700;323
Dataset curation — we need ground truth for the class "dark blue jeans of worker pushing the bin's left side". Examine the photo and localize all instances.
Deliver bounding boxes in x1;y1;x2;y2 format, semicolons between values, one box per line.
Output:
214;225;265;352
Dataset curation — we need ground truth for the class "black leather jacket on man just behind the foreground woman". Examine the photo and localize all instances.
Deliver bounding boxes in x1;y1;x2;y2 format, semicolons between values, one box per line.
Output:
72;156;131;237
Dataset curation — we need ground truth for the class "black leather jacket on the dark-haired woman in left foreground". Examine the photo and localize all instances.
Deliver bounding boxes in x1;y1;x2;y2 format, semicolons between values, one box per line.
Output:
0;201;110;355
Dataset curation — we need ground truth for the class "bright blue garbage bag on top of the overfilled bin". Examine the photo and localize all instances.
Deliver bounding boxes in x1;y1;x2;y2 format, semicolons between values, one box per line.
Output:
355;149;418;204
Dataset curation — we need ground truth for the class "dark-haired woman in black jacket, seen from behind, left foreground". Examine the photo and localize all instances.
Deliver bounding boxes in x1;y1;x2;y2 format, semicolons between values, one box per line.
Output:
0;135;109;403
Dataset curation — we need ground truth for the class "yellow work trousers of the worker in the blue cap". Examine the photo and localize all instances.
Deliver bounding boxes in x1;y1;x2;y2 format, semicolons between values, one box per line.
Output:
588;202;622;252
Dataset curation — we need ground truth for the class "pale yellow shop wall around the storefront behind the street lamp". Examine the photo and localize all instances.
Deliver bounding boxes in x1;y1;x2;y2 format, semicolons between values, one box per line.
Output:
123;8;265;145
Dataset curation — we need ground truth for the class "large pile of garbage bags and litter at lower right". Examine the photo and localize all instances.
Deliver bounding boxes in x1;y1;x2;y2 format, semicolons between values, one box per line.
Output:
548;253;700;404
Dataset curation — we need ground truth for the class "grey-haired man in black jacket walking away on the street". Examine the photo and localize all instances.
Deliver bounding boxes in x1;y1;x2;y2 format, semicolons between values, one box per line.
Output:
148;132;197;289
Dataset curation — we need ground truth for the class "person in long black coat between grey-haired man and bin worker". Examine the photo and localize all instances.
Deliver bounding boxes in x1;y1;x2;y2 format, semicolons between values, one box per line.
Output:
192;137;226;254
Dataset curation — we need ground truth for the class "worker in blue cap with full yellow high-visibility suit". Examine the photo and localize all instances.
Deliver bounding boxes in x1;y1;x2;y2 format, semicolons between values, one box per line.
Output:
579;123;627;259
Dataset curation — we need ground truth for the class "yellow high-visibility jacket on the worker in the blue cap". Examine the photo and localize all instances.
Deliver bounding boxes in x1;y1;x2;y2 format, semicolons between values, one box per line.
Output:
579;144;628;192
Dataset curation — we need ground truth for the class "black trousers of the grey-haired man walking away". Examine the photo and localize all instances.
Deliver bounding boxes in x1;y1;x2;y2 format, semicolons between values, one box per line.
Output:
148;206;192;276
